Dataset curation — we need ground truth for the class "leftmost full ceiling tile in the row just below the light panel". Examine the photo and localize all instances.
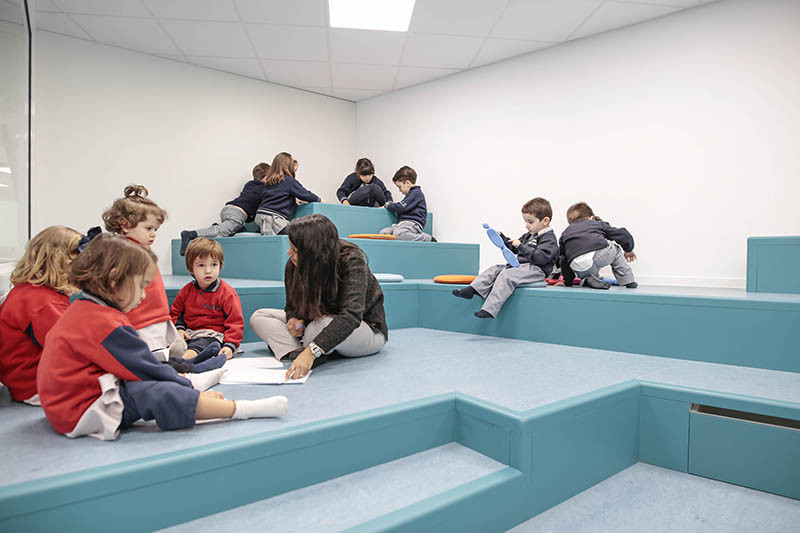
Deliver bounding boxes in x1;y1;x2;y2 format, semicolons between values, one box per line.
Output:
71;15;180;54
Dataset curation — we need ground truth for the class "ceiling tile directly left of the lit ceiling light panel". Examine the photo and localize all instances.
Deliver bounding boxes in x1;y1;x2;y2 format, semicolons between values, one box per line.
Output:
235;0;328;26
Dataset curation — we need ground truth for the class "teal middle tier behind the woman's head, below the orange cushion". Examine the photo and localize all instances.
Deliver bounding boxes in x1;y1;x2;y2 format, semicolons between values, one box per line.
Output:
172;235;480;280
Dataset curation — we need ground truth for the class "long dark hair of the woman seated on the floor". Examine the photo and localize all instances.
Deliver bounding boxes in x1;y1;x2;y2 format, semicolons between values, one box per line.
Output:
285;215;359;320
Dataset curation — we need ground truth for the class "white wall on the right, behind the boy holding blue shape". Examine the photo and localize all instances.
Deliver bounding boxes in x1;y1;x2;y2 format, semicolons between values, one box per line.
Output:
357;0;800;287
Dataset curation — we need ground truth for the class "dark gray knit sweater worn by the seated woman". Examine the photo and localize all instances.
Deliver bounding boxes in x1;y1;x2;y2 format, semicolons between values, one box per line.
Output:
284;242;389;352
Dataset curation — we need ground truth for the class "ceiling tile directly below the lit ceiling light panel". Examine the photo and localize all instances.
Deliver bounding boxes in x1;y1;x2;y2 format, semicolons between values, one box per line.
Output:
330;28;406;65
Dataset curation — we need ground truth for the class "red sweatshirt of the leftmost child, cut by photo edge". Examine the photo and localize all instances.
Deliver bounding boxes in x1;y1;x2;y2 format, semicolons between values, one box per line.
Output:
0;283;69;402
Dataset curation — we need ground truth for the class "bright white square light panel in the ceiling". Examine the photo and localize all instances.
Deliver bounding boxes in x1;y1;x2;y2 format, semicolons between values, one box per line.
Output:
328;0;416;31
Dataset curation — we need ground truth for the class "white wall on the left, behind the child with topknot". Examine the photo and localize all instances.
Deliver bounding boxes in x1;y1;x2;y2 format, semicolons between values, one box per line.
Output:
31;31;355;274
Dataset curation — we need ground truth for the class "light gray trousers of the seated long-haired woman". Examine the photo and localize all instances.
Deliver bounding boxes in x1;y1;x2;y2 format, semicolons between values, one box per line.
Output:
250;309;386;360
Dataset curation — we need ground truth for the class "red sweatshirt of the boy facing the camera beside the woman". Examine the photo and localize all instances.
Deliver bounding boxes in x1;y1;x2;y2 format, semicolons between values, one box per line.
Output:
172;279;244;351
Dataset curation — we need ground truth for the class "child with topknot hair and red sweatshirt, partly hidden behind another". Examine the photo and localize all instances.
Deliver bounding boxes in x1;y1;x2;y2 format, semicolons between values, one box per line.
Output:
103;185;186;361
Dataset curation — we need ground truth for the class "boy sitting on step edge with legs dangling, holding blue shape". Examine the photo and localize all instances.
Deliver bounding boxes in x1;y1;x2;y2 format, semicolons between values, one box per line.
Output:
453;198;558;318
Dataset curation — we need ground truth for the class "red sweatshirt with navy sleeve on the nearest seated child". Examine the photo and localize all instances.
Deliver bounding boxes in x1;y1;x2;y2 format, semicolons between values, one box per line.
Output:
37;293;192;433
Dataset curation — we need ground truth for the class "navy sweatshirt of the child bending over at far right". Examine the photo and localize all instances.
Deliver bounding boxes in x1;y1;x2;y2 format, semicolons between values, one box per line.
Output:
558;218;633;287
